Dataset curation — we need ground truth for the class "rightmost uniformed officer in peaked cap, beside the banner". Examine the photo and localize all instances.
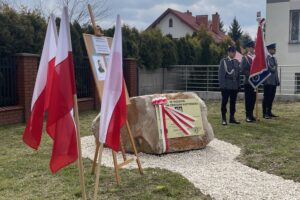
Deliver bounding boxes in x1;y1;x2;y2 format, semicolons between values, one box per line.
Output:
263;43;280;119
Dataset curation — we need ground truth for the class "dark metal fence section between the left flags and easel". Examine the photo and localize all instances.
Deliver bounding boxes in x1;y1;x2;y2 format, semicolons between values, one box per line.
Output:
75;60;93;98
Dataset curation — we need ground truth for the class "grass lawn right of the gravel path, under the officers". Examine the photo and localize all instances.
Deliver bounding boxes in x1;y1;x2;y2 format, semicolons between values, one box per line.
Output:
207;102;300;182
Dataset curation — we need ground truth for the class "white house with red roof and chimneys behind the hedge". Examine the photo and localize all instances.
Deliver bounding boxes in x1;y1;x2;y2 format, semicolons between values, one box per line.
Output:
147;8;226;42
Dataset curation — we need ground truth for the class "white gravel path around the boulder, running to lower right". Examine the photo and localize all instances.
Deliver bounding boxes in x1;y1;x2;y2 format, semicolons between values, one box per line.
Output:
81;136;300;200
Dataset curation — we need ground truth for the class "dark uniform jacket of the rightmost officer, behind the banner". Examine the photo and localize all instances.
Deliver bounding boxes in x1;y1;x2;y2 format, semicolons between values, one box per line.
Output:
264;55;280;86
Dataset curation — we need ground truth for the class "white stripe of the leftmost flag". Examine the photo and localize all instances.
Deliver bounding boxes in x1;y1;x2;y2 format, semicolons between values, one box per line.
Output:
31;14;57;110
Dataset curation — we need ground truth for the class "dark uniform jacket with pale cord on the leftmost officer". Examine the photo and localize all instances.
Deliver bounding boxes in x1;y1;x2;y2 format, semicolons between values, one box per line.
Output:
218;57;240;90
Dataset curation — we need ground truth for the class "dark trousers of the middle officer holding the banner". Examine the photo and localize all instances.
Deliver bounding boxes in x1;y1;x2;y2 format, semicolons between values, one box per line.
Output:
244;84;256;117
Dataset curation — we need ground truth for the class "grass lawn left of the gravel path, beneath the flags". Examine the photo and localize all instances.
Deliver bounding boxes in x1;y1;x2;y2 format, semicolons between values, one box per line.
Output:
0;112;211;200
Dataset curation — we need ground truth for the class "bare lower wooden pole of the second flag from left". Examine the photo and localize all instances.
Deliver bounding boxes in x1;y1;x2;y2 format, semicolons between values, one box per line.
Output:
73;94;86;200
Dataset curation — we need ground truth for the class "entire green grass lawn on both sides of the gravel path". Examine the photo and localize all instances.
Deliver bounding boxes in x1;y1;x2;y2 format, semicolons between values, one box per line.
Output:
0;102;300;200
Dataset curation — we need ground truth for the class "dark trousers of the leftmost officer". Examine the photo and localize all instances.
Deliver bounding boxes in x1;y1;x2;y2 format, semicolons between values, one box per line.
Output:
221;89;238;118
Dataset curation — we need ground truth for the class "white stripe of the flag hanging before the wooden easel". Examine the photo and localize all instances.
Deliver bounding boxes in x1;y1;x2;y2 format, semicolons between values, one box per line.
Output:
99;15;123;144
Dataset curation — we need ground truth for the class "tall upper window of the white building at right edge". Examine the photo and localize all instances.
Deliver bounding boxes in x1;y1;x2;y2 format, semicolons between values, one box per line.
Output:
290;10;300;43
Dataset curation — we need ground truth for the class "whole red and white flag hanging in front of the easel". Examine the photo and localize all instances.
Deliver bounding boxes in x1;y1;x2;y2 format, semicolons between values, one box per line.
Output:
99;15;127;151
